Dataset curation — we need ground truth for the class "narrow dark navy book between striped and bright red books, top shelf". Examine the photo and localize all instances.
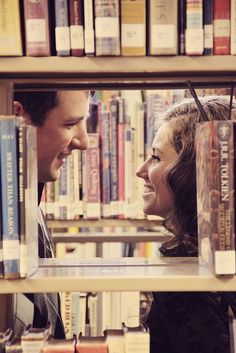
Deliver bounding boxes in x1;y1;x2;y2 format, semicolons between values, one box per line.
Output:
203;0;213;55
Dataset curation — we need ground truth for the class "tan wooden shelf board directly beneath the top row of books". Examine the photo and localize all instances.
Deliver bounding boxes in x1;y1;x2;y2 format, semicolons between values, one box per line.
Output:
0;55;236;89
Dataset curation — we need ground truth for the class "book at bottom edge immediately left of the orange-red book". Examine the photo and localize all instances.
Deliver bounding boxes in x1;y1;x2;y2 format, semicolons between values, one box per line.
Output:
41;337;76;353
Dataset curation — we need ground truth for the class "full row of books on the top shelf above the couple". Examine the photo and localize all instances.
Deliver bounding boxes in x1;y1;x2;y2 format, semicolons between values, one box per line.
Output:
0;0;236;56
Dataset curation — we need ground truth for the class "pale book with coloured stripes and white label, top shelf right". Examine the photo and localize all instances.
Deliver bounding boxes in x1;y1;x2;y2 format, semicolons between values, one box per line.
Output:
185;0;204;55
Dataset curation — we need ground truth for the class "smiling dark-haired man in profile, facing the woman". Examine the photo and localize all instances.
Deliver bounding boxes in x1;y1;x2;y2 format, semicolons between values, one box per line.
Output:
13;91;89;338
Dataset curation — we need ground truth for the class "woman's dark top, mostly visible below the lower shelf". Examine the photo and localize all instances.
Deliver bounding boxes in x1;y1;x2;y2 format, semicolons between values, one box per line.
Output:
147;236;231;353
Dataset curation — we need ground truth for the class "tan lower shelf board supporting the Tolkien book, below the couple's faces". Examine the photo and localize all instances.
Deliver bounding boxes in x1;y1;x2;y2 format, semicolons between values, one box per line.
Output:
0;258;236;293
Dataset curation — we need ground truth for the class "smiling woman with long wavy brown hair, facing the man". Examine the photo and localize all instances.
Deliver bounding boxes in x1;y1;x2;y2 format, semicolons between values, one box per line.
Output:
137;96;236;353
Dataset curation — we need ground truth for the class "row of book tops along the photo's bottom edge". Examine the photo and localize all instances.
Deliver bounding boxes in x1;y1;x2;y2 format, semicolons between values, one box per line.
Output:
0;324;150;353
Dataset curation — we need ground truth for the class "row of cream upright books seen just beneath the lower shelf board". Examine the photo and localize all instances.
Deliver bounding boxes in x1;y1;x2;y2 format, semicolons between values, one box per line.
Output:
61;291;152;338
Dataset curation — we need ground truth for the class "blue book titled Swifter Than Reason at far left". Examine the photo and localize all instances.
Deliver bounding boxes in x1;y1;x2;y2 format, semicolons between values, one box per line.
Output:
0;118;20;279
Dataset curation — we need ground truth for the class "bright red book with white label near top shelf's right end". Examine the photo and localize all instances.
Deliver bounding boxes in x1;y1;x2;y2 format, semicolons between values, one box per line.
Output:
213;0;230;55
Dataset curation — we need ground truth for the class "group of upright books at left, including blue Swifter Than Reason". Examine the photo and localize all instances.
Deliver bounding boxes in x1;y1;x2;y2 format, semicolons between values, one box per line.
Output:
0;116;38;279
